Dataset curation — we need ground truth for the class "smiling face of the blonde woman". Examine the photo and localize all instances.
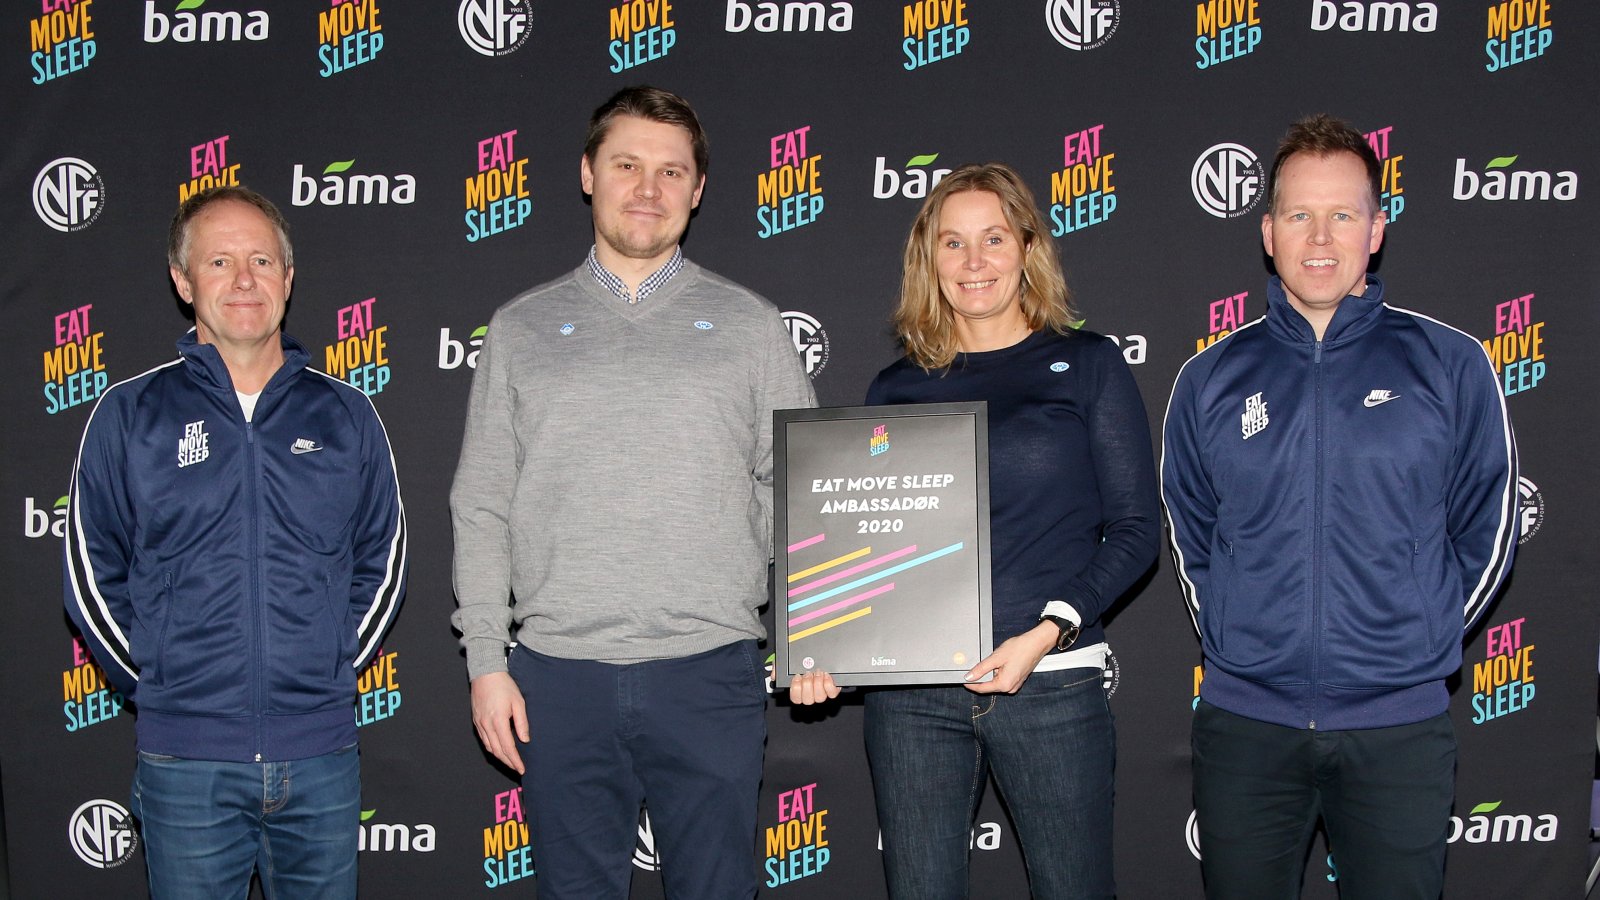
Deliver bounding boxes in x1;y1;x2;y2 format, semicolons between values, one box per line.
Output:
934;191;1026;328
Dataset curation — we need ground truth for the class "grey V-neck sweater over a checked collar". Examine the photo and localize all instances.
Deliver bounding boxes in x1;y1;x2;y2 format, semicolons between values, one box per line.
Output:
450;261;816;677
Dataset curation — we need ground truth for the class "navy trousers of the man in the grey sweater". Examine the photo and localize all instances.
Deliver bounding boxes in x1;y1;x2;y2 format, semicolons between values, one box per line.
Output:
507;641;766;900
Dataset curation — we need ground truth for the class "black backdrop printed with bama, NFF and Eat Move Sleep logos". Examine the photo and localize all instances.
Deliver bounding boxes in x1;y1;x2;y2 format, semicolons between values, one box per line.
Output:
0;0;1600;898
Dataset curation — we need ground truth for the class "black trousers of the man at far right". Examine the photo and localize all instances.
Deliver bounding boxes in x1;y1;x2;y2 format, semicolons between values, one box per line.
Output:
1190;700;1456;900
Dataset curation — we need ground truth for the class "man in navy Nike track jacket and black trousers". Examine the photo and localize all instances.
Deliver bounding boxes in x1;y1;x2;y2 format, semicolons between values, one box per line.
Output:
1162;115;1517;900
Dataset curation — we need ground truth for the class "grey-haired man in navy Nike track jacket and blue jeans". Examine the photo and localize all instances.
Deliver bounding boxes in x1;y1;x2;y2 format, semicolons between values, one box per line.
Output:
66;187;406;900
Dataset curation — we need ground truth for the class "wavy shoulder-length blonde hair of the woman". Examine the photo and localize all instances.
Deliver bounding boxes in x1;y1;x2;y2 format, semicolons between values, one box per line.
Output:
894;162;1077;370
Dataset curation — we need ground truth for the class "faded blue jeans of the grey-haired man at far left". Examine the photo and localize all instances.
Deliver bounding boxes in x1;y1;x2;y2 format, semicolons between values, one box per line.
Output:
133;743;362;900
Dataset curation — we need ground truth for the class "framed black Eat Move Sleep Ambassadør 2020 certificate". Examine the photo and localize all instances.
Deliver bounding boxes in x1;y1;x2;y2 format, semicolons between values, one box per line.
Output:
773;402;994;687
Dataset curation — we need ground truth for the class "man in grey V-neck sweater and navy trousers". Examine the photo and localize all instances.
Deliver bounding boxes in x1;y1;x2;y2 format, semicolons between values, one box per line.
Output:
450;86;816;900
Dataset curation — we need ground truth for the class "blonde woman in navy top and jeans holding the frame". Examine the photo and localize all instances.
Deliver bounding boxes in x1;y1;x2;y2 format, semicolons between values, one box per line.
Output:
790;163;1160;900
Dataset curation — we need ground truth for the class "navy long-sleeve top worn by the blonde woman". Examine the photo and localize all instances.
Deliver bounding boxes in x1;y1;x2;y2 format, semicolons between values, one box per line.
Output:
867;330;1160;647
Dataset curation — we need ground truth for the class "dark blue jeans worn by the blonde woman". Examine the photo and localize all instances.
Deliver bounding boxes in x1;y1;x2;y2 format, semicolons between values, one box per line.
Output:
864;668;1117;900
